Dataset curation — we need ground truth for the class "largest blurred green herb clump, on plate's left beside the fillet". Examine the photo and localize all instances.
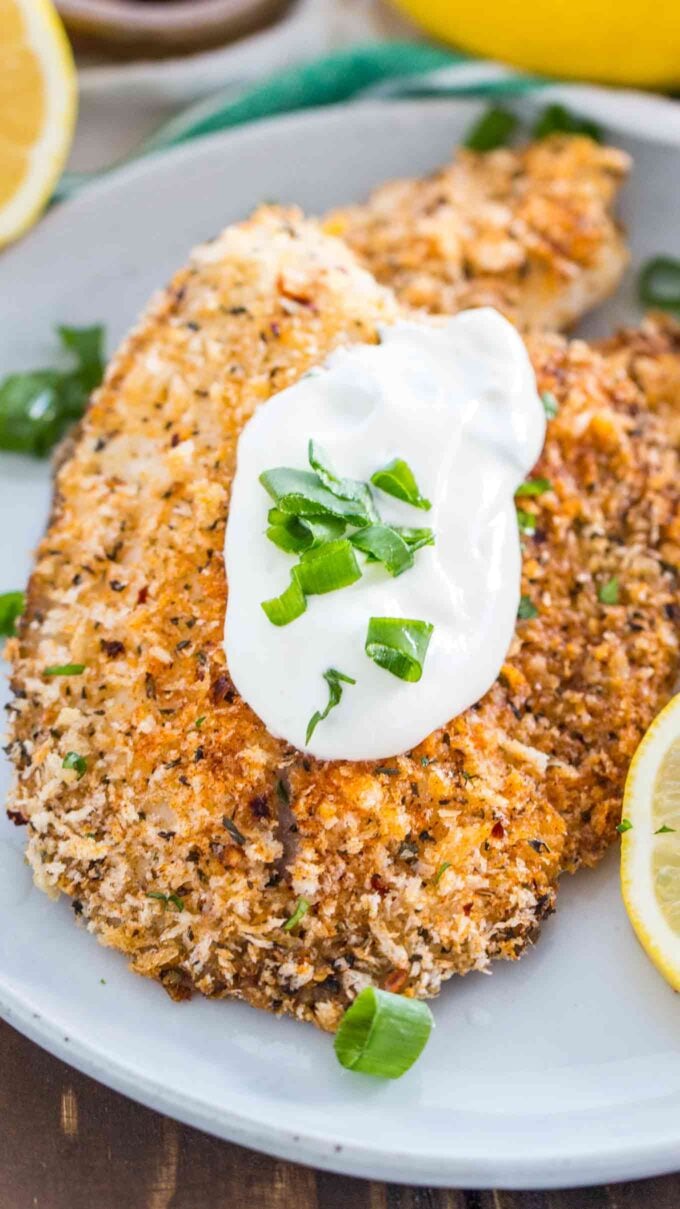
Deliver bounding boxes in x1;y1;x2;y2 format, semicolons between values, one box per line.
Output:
0;326;104;457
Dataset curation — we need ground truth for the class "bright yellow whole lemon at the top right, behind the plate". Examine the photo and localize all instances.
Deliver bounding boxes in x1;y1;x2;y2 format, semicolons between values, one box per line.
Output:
392;0;680;88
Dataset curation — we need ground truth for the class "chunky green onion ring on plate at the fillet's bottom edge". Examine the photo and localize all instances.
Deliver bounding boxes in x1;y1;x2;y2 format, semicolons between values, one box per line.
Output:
334;987;434;1078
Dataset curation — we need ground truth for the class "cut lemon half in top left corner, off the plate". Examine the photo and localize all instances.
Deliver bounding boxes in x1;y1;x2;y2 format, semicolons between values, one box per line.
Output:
0;0;76;247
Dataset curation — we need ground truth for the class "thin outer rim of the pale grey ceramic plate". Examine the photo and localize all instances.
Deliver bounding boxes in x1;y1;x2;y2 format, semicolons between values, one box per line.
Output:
0;98;680;1190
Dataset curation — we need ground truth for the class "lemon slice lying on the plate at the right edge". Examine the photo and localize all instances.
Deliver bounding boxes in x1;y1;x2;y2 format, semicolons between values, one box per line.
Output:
620;694;680;991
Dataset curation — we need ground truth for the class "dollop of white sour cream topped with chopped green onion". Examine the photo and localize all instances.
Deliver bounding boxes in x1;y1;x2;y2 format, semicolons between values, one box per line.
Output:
225;308;546;760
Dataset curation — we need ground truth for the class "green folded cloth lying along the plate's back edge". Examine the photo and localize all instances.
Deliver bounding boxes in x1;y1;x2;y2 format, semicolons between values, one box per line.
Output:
54;42;547;199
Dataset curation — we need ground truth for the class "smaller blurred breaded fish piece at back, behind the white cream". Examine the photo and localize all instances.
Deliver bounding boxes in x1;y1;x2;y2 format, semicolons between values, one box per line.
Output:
324;134;629;330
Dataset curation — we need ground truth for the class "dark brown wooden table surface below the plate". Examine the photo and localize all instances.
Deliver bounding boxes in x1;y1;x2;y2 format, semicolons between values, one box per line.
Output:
0;1022;680;1209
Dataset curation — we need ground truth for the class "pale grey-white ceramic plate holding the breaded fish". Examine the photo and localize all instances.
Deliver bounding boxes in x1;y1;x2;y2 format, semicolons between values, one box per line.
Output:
0;100;680;1187
